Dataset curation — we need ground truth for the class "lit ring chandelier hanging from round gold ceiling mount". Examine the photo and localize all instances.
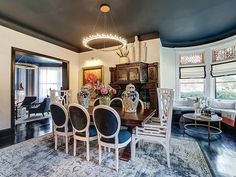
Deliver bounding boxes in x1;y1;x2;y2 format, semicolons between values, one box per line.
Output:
83;4;127;51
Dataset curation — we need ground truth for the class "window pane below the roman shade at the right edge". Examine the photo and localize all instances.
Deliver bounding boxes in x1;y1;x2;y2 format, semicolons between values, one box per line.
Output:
215;75;236;100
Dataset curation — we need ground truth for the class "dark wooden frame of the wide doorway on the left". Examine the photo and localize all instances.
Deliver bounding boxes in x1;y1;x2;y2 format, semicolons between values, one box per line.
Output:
11;47;70;133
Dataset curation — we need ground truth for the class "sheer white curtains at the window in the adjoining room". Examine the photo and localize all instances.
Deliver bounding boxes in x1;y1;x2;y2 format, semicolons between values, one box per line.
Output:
39;67;62;101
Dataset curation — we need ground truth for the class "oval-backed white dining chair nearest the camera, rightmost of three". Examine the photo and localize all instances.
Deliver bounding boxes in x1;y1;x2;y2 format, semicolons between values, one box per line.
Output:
93;105;131;171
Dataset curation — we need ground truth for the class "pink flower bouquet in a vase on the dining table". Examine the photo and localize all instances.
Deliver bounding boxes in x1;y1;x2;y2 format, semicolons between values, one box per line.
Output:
94;85;116;105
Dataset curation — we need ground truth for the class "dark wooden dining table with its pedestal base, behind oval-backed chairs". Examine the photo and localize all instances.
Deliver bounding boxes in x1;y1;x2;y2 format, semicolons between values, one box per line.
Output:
88;106;156;161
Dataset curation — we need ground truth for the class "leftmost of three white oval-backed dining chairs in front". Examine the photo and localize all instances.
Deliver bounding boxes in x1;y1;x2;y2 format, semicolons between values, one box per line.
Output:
50;103;73;154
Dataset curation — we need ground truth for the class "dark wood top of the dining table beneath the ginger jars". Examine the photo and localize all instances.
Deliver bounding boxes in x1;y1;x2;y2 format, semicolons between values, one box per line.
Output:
88;106;156;126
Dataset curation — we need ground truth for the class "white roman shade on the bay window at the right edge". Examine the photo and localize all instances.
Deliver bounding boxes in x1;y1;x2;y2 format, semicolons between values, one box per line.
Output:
211;60;236;77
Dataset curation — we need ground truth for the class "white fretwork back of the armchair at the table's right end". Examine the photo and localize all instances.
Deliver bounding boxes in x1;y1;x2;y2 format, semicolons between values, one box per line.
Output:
157;88;174;137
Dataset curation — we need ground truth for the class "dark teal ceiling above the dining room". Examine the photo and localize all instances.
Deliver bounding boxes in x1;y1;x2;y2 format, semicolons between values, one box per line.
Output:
0;0;236;52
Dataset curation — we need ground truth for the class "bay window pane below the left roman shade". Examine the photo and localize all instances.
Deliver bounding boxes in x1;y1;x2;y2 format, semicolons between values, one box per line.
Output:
180;79;205;98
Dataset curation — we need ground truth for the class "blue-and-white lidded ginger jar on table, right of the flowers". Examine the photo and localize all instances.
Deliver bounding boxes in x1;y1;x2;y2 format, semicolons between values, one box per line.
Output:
122;84;139;112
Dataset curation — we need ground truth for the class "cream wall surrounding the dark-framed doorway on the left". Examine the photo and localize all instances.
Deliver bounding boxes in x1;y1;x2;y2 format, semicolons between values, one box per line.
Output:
0;26;79;130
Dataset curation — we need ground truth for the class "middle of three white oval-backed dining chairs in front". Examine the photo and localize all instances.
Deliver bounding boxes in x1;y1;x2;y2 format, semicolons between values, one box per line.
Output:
69;103;97;161
